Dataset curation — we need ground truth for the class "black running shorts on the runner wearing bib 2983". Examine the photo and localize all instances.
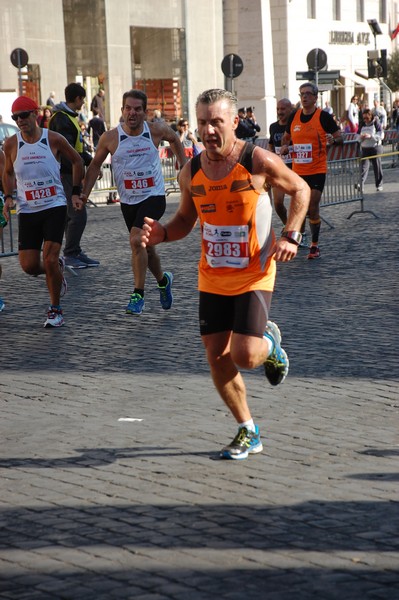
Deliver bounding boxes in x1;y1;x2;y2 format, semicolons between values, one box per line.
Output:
199;290;272;338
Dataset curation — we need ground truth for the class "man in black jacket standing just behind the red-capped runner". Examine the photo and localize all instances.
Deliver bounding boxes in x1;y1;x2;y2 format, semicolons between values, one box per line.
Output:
49;83;100;269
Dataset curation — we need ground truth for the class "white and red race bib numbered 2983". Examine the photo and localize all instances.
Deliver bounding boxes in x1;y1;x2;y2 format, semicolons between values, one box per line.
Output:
202;223;249;269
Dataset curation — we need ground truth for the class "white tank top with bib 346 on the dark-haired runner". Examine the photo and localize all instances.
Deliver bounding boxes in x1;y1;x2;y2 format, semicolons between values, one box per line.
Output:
111;121;165;204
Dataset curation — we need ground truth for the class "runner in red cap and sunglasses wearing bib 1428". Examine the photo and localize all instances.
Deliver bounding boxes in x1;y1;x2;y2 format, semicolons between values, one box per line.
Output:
3;96;84;328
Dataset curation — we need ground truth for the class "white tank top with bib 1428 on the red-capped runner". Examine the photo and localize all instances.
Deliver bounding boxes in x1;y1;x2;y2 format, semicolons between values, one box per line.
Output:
14;129;66;213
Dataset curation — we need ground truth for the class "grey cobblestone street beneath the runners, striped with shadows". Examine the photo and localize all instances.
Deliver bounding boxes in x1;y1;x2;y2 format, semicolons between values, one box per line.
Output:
0;171;399;600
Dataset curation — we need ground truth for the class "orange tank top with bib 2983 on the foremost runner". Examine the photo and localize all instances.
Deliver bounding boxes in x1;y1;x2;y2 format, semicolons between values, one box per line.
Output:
191;143;276;296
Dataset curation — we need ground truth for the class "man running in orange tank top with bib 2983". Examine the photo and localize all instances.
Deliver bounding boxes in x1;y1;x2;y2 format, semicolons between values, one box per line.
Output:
142;89;310;460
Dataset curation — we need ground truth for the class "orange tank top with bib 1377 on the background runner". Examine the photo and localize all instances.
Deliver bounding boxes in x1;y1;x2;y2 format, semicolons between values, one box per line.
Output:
291;108;327;175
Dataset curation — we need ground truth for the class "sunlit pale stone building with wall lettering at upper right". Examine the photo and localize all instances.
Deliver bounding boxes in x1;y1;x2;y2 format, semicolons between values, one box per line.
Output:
227;0;399;135
